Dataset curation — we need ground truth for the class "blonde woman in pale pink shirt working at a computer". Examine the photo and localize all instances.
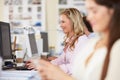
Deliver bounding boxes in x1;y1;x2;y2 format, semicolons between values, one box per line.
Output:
51;8;88;74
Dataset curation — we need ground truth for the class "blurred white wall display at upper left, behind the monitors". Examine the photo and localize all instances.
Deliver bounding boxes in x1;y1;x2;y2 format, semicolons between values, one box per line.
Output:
4;0;46;31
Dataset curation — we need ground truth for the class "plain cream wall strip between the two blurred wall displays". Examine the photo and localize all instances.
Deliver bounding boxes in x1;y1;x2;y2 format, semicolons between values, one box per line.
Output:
46;0;58;51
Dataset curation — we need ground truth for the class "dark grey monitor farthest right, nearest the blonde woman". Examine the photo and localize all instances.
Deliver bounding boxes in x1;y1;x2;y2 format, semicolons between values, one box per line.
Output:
40;32;49;52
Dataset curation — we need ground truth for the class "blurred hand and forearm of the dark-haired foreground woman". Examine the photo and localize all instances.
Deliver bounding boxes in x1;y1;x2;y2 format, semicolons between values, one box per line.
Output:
36;60;73;80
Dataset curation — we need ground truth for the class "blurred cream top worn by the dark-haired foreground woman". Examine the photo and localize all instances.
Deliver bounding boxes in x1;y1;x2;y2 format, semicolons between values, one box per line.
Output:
72;38;120;80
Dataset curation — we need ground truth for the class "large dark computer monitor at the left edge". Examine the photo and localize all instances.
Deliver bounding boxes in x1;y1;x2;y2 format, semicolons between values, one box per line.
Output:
0;22;12;59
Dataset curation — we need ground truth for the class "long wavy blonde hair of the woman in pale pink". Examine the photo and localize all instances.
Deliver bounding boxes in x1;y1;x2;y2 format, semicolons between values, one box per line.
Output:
60;8;85;50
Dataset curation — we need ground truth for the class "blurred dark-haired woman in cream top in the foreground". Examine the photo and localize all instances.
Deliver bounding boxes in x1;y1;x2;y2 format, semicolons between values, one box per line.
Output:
34;0;120;80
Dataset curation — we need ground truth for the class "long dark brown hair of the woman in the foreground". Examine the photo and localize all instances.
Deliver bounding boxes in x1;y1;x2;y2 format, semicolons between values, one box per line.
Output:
95;0;120;80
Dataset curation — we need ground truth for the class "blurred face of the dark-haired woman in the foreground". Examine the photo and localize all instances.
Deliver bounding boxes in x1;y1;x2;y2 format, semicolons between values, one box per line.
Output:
86;0;113;32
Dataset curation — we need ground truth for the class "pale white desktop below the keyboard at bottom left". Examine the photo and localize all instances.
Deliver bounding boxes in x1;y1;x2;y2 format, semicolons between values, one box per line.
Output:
0;70;41;80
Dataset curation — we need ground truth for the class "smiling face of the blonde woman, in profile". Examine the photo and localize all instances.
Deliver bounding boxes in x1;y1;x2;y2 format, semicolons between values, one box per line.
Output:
60;15;73;34
